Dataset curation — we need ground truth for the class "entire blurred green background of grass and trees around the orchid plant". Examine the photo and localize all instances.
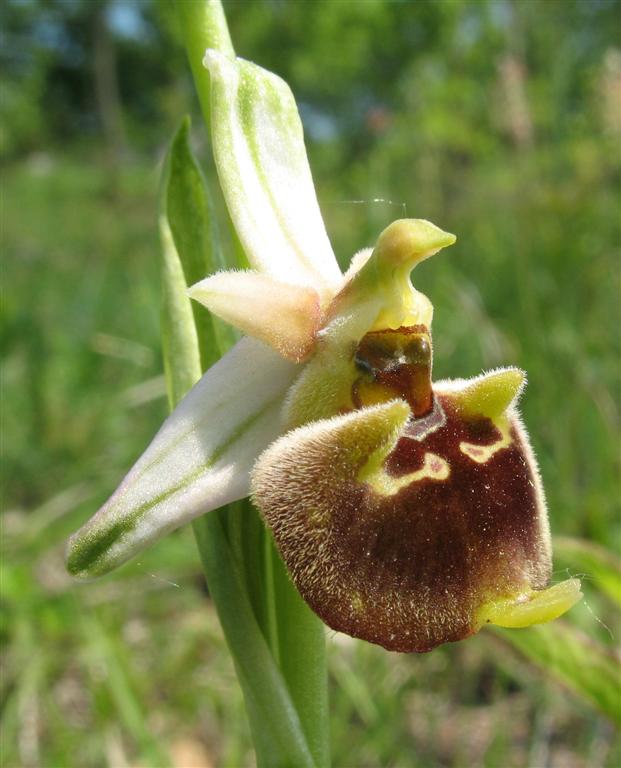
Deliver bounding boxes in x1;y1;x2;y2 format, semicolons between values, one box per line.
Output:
0;0;621;768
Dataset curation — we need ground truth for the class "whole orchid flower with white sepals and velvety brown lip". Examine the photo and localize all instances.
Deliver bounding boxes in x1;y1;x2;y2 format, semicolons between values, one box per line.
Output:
67;50;580;651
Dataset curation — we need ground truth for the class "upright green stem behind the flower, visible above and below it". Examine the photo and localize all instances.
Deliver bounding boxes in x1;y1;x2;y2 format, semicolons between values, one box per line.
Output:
175;0;330;768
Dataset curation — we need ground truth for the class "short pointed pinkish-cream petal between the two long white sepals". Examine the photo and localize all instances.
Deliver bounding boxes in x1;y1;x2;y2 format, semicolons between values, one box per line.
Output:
188;272;320;363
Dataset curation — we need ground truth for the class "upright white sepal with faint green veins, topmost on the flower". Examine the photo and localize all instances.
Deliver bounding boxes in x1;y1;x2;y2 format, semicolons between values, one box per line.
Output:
204;50;342;300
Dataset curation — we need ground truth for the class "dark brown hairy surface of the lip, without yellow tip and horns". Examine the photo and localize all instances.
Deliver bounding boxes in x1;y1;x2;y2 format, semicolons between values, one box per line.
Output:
252;394;550;652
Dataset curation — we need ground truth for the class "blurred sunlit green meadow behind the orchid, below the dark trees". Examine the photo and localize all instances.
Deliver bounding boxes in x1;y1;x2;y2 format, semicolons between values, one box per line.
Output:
0;4;621;768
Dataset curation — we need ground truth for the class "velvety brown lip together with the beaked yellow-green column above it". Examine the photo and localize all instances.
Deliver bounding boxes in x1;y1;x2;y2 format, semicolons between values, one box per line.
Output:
253;220;579;651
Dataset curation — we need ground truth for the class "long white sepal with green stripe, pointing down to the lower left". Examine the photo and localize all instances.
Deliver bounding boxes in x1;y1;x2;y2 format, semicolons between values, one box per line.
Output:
67;338;297;577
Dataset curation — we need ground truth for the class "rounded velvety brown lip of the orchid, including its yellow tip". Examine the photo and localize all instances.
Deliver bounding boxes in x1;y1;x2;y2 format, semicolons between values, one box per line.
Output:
252;370;568;652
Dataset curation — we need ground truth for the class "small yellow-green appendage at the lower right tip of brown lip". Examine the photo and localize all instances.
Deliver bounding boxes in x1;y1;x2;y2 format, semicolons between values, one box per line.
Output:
479;579;582;628
